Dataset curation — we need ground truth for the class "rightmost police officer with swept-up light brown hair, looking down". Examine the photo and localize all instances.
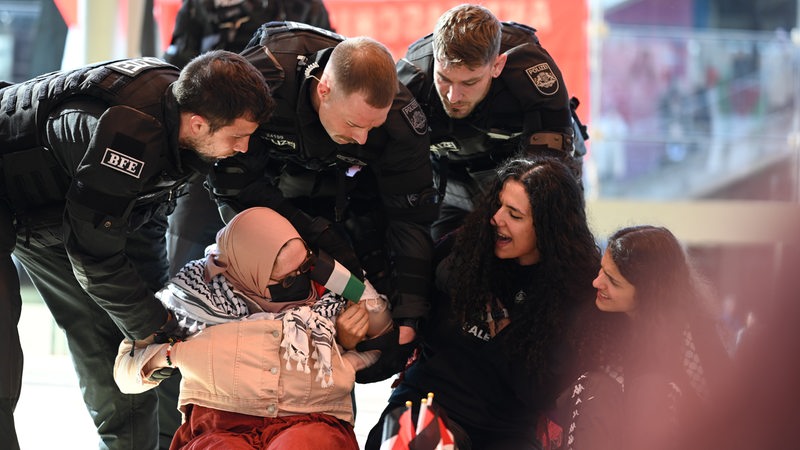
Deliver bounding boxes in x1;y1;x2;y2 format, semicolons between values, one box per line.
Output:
397;4;588;240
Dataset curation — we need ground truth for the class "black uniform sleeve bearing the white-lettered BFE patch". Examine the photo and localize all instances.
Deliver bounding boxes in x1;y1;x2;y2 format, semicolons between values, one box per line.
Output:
55;106;172;339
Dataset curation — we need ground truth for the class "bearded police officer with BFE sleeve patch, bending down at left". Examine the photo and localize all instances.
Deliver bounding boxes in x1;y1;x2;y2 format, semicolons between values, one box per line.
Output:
0;51;273;449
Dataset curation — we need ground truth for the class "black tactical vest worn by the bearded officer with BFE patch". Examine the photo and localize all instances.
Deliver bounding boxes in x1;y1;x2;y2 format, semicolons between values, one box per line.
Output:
0;58;180;229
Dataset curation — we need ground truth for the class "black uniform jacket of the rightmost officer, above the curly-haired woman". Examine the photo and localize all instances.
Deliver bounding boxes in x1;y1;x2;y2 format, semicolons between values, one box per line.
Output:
397;22;576;194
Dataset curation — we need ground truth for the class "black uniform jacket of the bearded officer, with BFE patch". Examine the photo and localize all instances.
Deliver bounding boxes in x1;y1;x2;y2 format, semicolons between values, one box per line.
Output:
0;58;202;339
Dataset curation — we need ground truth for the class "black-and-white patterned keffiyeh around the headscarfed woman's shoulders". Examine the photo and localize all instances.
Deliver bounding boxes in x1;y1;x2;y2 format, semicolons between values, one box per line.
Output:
156;260;346;387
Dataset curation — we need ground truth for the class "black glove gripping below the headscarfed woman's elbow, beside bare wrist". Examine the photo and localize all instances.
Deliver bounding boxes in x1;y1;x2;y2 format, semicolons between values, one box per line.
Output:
356;326;417;383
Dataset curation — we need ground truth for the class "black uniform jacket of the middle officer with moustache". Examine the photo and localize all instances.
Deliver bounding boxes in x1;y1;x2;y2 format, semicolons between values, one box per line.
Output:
212;22;438;319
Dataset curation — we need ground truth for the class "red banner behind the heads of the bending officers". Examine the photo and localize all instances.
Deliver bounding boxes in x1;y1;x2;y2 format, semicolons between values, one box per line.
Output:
325;0;590;122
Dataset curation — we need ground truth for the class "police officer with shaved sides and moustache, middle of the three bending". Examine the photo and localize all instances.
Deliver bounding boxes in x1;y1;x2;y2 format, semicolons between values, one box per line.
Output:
211;22;438;382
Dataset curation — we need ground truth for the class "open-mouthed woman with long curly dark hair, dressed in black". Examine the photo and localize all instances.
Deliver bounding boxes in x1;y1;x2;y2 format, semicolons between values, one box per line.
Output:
366;157;600;450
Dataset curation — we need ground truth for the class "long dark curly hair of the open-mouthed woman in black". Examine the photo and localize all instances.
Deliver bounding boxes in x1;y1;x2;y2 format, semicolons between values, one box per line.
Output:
448;156;600;382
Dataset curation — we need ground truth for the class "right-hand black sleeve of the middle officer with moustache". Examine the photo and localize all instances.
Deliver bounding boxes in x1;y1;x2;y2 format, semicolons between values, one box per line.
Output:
368;87;439;323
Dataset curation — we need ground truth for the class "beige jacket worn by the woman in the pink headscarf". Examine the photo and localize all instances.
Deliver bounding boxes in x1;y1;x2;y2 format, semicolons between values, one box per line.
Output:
114;320;355;424
